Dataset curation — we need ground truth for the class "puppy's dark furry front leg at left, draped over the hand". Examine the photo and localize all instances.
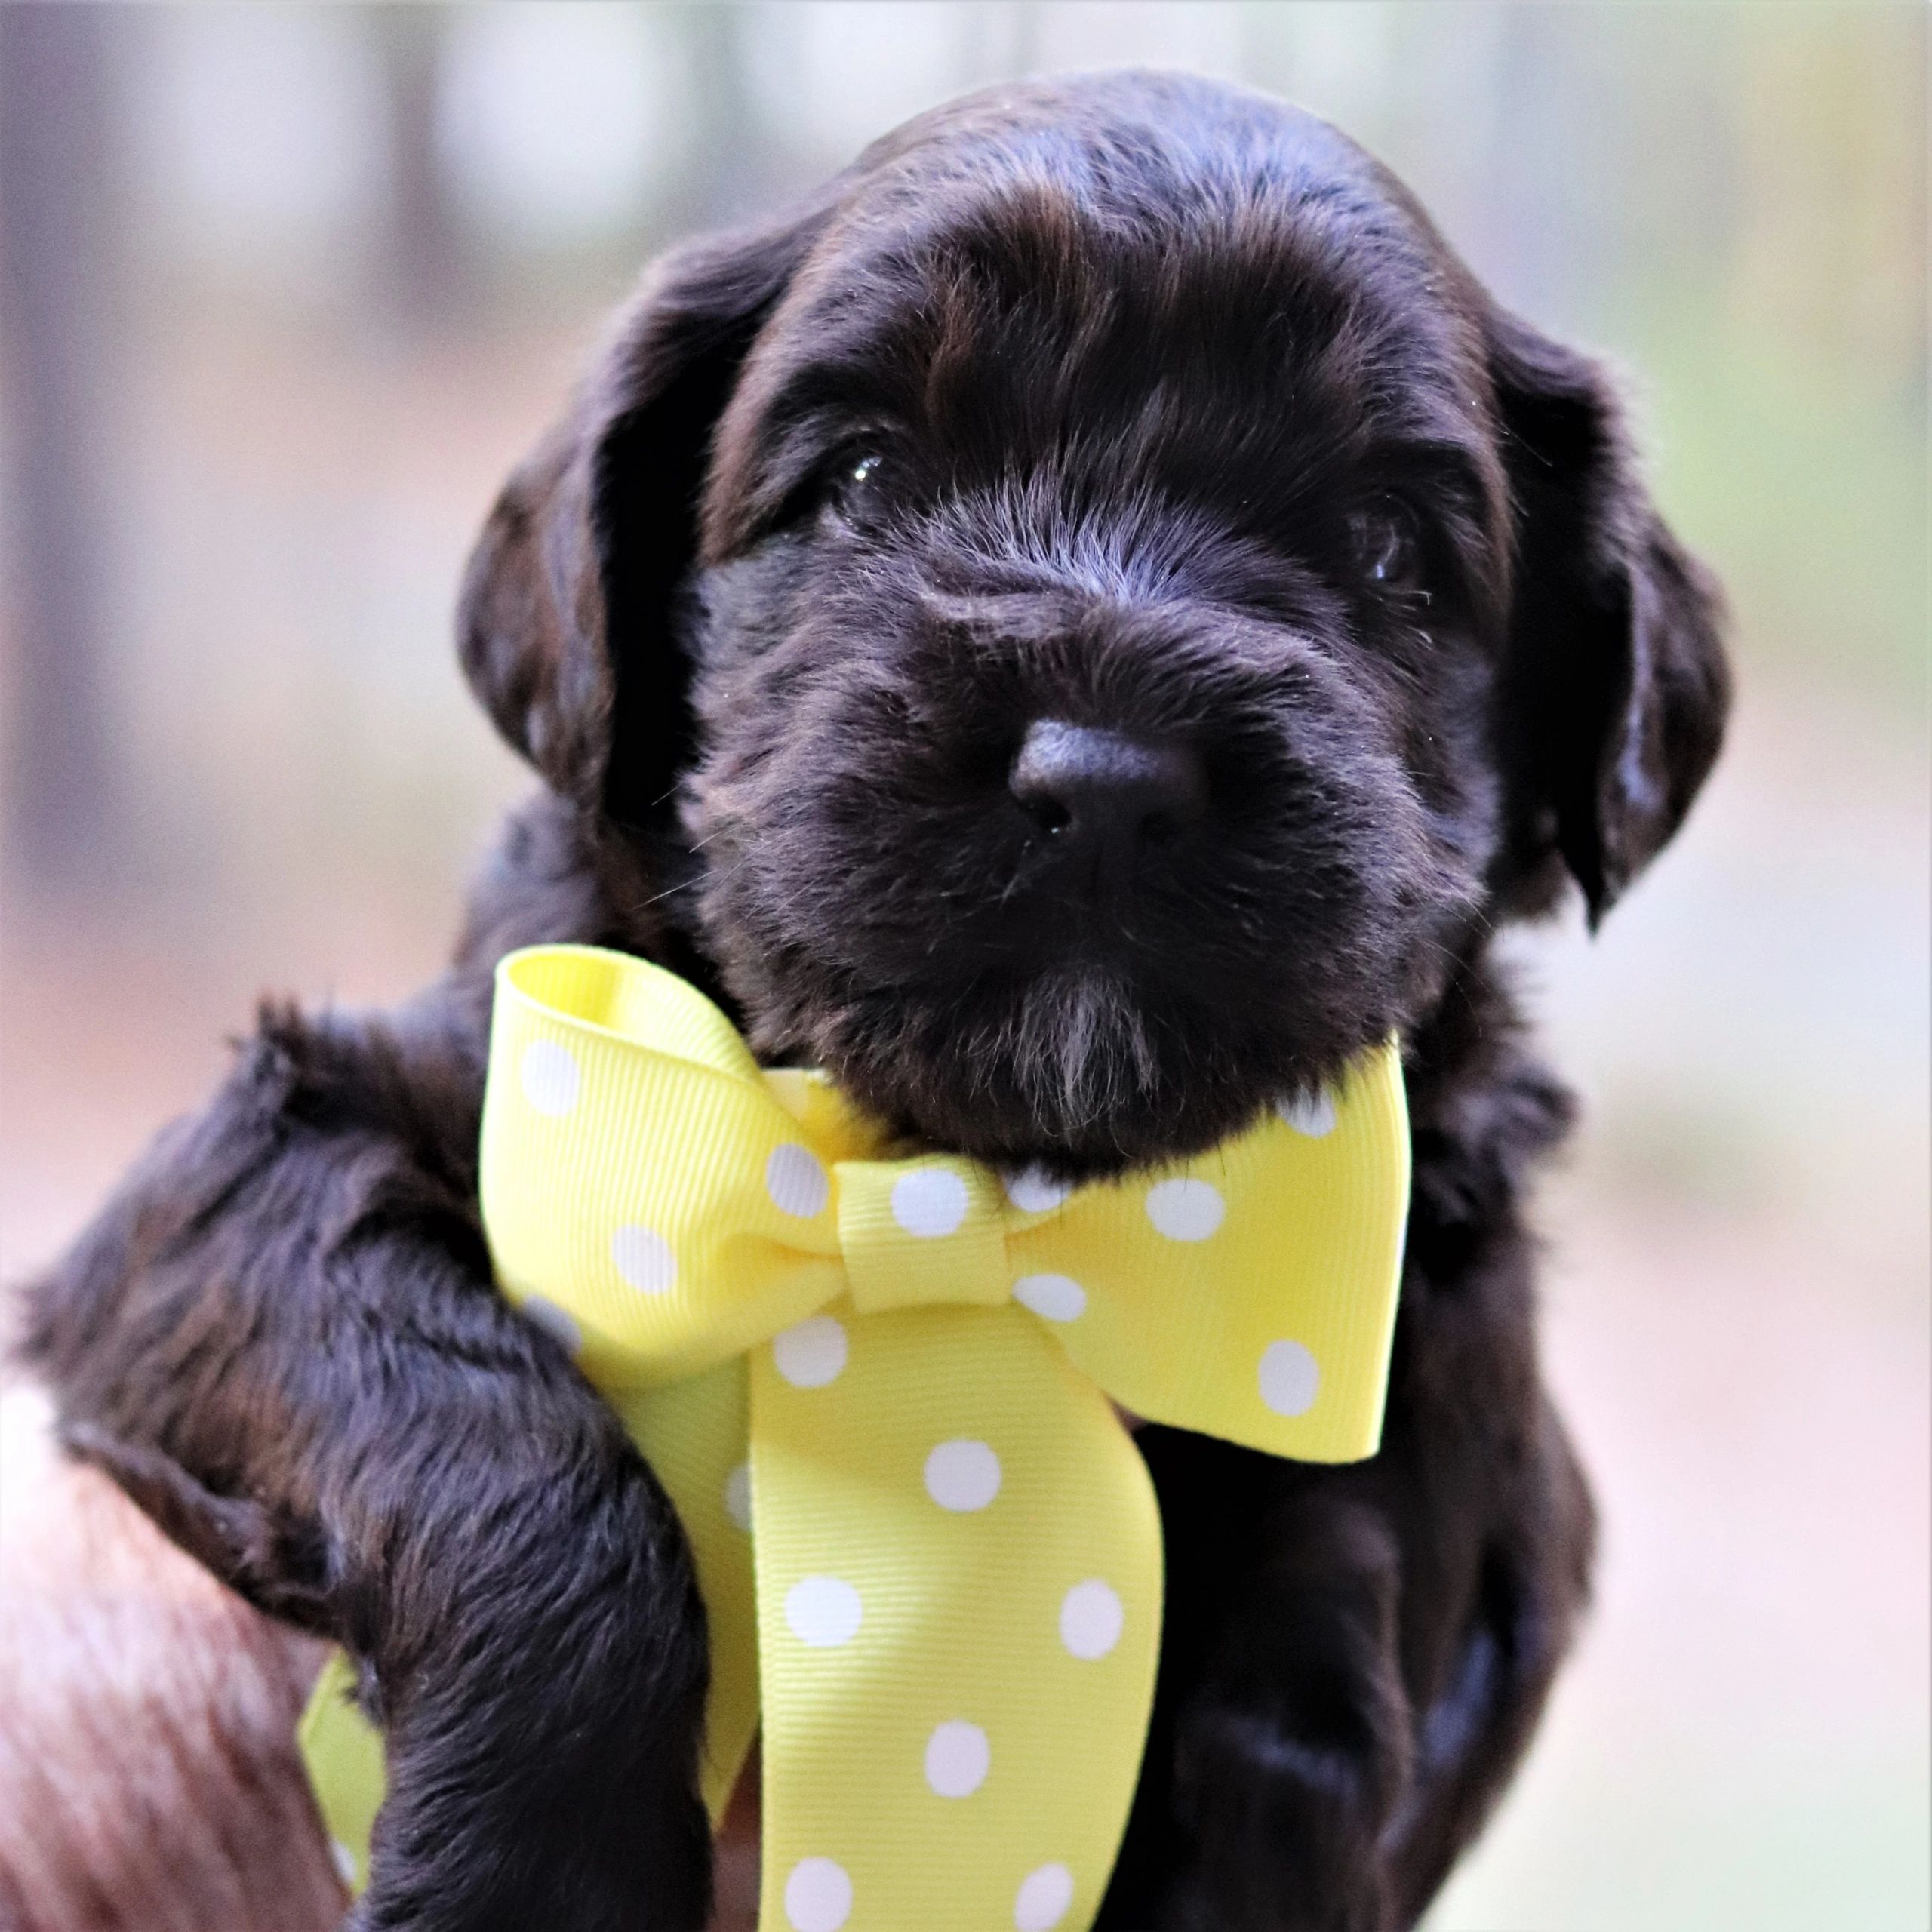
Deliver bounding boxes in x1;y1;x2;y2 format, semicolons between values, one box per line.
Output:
25;993;709;1932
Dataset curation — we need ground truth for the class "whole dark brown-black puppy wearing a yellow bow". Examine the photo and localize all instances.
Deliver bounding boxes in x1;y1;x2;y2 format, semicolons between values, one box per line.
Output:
27;75;1727;1932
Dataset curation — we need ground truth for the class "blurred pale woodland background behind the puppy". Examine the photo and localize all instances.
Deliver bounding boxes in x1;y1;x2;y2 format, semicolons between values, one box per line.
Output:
0;0;1932;1932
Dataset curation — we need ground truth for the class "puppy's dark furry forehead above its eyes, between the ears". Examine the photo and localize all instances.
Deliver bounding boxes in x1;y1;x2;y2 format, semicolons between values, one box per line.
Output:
713;103;1487;541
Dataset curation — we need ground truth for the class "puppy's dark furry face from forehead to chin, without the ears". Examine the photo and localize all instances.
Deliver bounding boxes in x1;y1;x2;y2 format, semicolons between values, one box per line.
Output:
686;182;1507;1165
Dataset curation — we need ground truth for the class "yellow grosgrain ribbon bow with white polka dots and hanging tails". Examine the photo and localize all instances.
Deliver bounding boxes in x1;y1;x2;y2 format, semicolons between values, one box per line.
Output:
303;946;1408;1932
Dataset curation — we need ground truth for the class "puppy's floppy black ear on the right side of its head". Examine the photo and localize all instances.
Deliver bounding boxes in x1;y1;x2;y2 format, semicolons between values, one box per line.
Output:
1490;313;1731;925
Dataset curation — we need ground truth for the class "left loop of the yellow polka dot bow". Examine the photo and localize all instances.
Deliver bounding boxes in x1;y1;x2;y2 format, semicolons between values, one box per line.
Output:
479;946;844;1391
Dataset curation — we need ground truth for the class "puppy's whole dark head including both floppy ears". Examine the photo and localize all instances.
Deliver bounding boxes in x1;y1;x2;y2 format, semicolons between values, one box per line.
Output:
463;75;1727;1171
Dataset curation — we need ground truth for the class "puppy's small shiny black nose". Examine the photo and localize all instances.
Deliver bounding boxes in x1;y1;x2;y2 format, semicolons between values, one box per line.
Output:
1007;718;1208;858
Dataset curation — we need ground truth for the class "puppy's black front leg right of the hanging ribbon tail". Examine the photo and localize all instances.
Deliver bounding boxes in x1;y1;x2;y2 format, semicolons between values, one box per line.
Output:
1101;1429;1412;1932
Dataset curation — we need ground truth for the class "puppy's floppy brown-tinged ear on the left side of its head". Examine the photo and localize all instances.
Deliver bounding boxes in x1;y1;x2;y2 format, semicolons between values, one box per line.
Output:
458;205;825;825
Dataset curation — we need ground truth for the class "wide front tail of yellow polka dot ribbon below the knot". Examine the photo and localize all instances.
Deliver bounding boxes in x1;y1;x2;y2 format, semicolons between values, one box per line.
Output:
752;1306;1163;1932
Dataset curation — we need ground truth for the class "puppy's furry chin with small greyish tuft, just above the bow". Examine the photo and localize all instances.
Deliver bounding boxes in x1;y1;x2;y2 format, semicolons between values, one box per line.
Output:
690;852;1445;1180
